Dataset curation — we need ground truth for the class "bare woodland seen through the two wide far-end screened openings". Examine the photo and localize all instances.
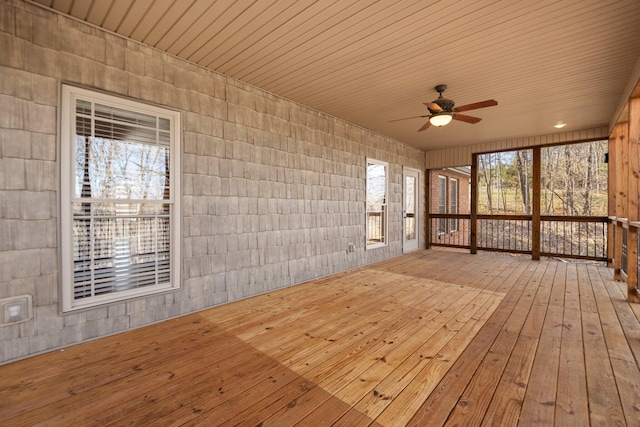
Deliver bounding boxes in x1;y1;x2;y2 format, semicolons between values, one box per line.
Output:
478;141;607;257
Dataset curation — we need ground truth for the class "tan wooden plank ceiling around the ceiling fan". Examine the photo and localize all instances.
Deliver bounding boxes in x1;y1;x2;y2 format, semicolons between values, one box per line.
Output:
34;0;640;149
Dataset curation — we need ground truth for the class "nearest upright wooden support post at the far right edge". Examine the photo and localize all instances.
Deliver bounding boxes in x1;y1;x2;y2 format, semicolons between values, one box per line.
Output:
627;98;640;303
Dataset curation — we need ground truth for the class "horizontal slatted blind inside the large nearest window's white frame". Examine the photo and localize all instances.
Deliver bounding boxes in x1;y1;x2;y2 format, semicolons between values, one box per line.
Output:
72;99;171;301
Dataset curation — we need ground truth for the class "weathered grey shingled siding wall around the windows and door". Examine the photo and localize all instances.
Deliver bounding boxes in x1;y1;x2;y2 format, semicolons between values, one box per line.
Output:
0;0;425;362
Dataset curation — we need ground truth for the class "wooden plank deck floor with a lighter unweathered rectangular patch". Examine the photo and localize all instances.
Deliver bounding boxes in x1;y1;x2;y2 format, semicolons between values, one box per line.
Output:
0;250;640;426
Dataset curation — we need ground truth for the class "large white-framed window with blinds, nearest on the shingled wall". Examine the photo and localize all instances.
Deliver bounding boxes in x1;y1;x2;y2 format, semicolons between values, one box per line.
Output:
60;85;180;311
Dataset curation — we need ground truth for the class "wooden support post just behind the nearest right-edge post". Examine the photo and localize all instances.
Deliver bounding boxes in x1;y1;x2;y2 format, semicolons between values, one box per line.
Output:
613;122;629;280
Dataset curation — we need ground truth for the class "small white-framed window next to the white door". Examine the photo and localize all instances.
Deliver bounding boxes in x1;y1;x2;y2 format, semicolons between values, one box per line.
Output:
366;159;389;249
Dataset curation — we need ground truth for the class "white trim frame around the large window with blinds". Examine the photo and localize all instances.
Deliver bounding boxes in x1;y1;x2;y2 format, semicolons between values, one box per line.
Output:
59;84;181;312
